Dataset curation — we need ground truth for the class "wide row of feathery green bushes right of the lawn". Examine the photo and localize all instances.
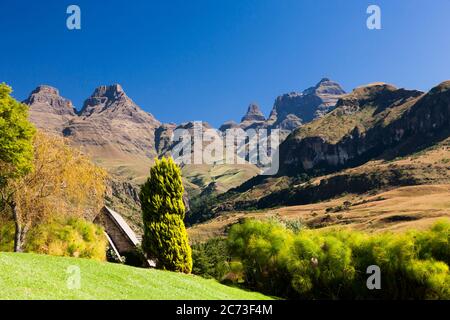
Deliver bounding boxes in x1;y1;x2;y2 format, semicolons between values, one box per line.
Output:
228;220;450;299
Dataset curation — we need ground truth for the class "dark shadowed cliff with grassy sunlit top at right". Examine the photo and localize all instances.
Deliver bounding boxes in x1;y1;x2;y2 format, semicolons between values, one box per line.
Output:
280;82;450;175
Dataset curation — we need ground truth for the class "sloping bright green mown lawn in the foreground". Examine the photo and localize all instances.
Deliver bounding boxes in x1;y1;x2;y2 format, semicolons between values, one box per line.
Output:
0;253;269;300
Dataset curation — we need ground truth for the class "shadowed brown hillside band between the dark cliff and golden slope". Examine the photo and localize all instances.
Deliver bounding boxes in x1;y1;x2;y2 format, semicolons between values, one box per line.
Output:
189;138;450;225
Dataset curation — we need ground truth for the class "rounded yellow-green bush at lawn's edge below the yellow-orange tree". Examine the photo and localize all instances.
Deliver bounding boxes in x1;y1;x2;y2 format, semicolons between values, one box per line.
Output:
25;218;107;261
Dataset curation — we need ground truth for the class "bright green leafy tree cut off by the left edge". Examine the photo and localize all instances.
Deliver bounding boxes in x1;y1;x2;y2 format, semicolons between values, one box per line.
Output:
0;83;35;251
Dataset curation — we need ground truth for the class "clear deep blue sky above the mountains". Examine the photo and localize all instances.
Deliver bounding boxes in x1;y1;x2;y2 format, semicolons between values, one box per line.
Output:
0;0;450;126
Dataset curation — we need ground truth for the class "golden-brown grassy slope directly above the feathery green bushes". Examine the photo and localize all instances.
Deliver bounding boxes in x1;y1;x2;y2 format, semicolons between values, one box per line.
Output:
188;184;450;242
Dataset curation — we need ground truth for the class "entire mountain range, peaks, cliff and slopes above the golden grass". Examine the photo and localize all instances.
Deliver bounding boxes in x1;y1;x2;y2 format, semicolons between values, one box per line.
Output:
24;78;450;236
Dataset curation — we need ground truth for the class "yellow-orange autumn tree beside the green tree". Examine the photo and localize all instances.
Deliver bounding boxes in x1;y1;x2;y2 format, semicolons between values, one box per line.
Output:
0;132;106;251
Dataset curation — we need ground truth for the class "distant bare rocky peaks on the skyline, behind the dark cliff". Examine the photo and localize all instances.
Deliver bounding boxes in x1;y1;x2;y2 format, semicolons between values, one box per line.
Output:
24;79;344;183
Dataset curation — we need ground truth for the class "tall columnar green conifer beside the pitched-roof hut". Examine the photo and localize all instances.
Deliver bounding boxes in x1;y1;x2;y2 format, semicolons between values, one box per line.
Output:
140;158;192;273
